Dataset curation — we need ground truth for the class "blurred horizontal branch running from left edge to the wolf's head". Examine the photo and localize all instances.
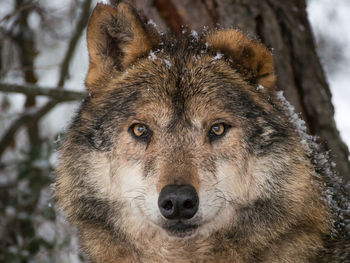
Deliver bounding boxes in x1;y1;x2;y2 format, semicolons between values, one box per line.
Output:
0;82;85;102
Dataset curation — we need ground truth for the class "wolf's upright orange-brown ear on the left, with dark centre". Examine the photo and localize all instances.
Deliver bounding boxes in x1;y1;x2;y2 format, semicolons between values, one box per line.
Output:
86;2;157;91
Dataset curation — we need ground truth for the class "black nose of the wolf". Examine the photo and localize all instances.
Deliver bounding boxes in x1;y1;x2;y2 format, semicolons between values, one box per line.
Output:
158;184;199;219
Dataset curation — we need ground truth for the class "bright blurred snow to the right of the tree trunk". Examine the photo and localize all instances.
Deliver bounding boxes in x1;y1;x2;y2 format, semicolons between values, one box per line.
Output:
307;0;350;146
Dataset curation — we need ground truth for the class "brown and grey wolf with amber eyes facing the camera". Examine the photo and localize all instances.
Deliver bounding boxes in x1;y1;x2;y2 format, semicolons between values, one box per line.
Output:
56;2;350;263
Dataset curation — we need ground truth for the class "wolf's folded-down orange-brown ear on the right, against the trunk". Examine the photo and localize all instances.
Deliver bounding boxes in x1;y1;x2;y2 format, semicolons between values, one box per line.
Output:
205;29;276;90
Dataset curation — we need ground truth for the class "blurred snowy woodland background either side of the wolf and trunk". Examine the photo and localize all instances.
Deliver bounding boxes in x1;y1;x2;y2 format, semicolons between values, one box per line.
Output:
0;0;350;262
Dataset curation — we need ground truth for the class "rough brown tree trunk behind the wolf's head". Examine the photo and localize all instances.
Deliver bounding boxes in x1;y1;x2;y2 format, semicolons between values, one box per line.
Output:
131;0;350;184
